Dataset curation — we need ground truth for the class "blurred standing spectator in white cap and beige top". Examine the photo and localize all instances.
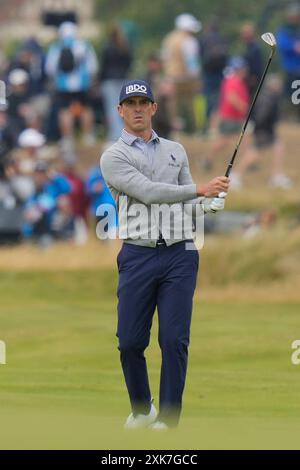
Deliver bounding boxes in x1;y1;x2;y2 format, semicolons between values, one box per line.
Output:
162;13;201;132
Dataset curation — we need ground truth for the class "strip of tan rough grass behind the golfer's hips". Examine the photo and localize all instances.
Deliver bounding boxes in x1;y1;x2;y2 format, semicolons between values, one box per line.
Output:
0;227;300;300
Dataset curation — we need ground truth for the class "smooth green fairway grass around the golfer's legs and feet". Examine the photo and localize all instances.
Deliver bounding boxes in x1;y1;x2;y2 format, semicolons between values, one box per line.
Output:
0;270;300;449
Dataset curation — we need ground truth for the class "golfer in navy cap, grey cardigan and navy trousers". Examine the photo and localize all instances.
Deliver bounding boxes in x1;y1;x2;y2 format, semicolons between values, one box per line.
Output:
100;80;229;429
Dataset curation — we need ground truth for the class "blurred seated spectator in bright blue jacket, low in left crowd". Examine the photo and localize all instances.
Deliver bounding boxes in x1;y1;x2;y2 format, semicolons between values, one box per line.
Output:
24;161;74;246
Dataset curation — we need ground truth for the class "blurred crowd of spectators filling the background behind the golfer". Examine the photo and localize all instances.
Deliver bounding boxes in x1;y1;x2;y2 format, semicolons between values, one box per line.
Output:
0;4;300;246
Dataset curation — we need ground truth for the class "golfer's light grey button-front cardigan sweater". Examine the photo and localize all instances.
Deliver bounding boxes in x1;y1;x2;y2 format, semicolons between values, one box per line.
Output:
100;138;203;247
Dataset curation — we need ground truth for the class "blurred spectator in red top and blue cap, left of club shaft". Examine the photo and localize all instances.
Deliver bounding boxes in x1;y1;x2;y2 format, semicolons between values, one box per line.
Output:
203;56;250;170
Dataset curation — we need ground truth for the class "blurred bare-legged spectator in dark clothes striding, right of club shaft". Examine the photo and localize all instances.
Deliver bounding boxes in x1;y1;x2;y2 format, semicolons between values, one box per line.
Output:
230;75;292;189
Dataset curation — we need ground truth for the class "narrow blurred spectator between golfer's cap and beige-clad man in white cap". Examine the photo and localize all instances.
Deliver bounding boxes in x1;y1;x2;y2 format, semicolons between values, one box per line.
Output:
145;54;173;139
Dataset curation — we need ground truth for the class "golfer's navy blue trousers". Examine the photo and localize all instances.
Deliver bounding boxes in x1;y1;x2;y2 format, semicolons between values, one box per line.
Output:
117;242;199;426
